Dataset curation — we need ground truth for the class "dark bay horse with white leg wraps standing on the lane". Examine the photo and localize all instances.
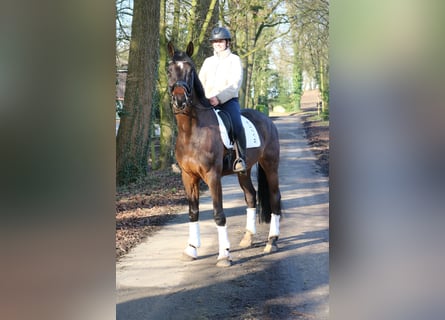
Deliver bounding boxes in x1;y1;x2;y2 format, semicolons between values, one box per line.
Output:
167;42;281;267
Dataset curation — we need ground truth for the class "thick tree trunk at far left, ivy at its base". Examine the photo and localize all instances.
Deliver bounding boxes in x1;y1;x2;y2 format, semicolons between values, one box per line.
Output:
116;0;160;185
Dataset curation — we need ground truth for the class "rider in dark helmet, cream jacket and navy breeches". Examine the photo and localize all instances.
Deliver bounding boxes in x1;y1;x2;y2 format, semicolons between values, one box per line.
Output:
199;27;246;173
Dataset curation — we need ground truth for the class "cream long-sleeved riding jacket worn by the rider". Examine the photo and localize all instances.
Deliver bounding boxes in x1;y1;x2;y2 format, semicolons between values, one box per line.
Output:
199;48;243;103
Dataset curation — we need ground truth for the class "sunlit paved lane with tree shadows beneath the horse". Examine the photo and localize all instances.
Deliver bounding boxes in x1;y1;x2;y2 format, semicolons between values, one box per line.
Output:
116;116;329;320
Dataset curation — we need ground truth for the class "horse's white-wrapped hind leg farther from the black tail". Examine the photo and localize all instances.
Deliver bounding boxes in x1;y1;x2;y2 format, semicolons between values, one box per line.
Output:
238;169;256;248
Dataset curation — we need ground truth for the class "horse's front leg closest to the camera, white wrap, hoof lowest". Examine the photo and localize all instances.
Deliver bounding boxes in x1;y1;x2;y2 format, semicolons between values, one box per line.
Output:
207;173;232;267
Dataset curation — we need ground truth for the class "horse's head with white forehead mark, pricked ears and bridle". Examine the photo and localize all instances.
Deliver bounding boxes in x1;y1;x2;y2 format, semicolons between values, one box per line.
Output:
167;42;195;113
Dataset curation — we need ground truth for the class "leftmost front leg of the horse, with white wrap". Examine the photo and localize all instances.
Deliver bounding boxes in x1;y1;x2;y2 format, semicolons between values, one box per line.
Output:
182;171;201;260
